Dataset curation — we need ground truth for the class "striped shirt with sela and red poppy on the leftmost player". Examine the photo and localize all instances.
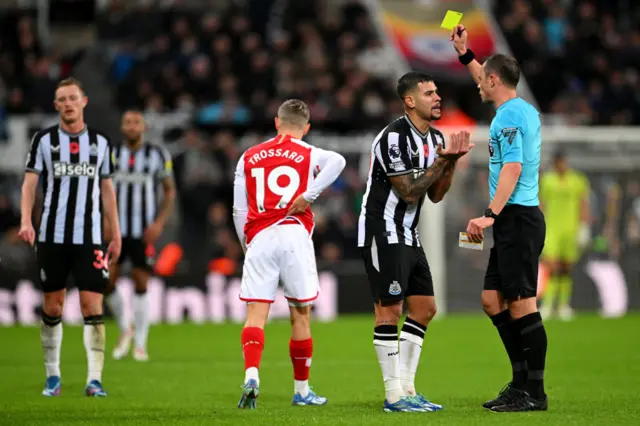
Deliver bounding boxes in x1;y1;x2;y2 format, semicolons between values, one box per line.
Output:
26;125;113;245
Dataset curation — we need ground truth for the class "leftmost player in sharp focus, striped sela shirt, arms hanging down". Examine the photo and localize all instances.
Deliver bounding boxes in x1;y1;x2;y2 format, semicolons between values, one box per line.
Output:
20;79;121;396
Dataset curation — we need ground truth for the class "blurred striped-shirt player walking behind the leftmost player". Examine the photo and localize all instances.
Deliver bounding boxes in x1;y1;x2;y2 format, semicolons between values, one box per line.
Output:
106;111;176;361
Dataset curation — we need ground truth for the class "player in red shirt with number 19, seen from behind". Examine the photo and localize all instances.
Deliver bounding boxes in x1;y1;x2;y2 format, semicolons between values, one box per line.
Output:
233;99;346;408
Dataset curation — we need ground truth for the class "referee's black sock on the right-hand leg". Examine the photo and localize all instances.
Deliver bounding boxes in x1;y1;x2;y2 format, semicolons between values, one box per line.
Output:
513;312;547;399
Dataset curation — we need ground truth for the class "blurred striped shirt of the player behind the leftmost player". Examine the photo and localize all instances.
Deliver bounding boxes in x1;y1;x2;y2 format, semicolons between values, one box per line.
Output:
114;142;173;238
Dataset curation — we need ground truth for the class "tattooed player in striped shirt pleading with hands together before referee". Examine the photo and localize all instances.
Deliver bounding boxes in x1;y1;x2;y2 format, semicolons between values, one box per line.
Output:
358;72;472;412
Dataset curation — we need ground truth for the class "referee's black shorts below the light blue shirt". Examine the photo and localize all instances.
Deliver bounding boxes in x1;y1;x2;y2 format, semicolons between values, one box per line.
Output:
484;205;546;300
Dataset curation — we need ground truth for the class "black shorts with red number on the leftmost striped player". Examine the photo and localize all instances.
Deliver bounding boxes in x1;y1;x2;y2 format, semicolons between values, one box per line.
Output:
36;243;109;293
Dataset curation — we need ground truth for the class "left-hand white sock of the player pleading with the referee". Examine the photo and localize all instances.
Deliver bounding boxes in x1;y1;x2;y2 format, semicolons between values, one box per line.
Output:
373;325;403;404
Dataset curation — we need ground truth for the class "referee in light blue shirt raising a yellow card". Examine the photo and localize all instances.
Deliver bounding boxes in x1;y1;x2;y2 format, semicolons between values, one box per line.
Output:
451;25;548;412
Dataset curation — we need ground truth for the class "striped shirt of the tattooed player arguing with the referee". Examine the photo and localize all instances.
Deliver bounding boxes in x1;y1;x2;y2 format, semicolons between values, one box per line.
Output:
358;116;445;247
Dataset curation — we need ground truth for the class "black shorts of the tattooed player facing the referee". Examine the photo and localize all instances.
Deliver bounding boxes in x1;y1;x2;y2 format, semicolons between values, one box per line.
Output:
362;237;433;306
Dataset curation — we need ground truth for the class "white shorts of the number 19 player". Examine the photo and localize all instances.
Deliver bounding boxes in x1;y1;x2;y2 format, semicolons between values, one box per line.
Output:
240;224;320;306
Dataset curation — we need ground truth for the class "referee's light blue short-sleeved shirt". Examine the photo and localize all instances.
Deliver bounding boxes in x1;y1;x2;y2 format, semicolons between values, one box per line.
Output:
489;98;542;206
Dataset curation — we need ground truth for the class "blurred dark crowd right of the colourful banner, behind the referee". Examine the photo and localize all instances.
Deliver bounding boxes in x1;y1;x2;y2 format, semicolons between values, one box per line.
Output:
494;0;640;125
